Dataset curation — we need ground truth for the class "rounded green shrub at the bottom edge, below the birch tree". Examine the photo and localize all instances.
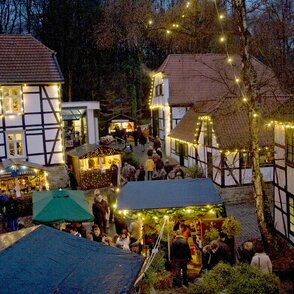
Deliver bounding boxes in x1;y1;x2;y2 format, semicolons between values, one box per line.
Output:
188;263;279;294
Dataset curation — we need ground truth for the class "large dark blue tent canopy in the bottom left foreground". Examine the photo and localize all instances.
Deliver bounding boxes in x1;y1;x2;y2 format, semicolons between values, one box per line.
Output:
0;226;144;294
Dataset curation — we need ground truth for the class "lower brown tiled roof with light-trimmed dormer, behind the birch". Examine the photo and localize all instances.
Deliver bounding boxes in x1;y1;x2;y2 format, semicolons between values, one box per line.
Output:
170;97;286;150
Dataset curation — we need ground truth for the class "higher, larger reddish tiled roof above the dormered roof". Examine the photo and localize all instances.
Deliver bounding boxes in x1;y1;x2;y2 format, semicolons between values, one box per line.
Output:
157;54;282;105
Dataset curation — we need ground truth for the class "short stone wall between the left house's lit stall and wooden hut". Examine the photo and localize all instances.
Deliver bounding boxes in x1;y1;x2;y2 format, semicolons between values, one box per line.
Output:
47;165;69;190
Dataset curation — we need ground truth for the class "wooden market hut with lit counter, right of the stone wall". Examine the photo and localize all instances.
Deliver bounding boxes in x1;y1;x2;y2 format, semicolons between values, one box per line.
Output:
67;144;121;190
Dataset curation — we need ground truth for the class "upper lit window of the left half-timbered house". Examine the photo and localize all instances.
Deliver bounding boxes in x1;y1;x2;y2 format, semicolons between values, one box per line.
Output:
1;86;23;114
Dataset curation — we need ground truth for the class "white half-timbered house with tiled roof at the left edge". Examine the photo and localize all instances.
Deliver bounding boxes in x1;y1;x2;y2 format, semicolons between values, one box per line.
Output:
0;35;64;191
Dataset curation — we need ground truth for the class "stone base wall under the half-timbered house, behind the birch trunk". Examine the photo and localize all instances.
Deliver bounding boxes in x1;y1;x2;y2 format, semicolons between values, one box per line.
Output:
216;183;273;207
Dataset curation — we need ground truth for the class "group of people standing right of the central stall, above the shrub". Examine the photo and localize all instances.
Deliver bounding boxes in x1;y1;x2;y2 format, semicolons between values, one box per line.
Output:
172;220;272;287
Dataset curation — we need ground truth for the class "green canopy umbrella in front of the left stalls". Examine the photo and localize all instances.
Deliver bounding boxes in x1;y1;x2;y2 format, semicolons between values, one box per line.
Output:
33;189;94;224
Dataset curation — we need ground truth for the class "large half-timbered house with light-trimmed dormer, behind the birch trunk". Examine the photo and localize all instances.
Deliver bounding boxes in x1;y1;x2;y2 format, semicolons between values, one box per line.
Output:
150;54;285;187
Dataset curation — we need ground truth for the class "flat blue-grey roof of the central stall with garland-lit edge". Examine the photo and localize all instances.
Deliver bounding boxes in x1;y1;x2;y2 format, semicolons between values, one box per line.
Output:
118;178;222;210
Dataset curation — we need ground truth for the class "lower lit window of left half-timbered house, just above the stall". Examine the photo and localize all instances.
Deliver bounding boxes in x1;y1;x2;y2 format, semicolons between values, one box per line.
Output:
6;131;25;158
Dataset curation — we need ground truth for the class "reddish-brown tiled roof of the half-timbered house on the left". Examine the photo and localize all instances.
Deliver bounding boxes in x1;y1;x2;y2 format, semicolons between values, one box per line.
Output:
0;34;63;84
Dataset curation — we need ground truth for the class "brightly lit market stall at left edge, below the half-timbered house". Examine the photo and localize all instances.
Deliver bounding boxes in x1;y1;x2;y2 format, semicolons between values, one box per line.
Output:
0;159;49;197
